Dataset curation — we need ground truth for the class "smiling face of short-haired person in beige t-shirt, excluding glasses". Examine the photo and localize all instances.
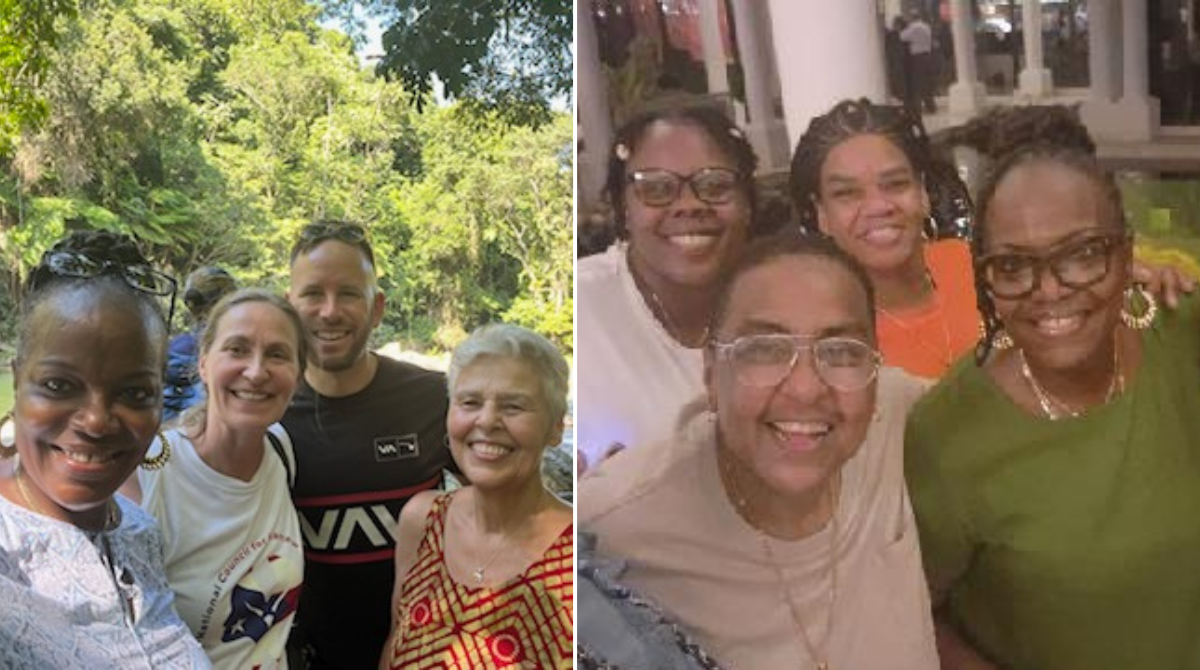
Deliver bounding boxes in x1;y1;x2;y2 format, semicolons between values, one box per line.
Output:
704;253;876;513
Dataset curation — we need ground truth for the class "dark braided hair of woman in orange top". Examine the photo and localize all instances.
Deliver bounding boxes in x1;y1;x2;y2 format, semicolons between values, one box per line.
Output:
788;97;971;233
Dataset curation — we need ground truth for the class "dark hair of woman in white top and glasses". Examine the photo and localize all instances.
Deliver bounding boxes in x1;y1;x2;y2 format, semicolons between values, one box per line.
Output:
604;106;758;239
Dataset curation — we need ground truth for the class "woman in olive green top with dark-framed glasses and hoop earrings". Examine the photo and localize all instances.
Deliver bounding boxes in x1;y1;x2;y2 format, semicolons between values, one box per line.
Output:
906;146;1200;670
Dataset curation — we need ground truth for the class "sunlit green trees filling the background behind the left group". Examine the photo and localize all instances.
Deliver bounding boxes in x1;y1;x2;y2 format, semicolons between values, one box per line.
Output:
0;0;571;348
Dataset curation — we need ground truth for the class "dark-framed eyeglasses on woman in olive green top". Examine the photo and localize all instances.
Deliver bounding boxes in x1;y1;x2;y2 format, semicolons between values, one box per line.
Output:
979;233;1132;300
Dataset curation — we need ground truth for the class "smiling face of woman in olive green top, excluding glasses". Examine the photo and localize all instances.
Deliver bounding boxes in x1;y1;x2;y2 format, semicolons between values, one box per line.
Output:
979;160;1133;377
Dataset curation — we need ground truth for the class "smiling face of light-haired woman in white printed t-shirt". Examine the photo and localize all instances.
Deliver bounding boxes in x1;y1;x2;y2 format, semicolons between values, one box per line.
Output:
199;300;302;435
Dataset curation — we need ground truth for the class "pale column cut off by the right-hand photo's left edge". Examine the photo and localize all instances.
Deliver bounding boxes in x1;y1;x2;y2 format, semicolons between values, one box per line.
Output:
575;0;612;213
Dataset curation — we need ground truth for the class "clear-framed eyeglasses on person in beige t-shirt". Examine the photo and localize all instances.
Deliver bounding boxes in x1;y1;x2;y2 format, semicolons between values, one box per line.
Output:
712;334;881;391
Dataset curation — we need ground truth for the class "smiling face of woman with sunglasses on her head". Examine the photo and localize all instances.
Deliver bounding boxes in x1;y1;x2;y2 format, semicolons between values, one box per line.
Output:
10;280;167;528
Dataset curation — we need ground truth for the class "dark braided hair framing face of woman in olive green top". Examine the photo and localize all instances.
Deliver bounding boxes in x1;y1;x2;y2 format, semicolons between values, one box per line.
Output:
971;142;1129;365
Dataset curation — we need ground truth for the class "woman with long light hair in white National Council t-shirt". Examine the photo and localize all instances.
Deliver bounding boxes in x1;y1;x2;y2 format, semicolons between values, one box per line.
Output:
127;288;306;669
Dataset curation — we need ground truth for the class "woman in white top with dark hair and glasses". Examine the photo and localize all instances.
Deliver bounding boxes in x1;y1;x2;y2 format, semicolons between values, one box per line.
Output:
576;107;757;473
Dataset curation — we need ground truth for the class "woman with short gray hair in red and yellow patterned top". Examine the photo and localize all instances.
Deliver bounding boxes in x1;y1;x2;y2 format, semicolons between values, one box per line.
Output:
379;324;574;669
